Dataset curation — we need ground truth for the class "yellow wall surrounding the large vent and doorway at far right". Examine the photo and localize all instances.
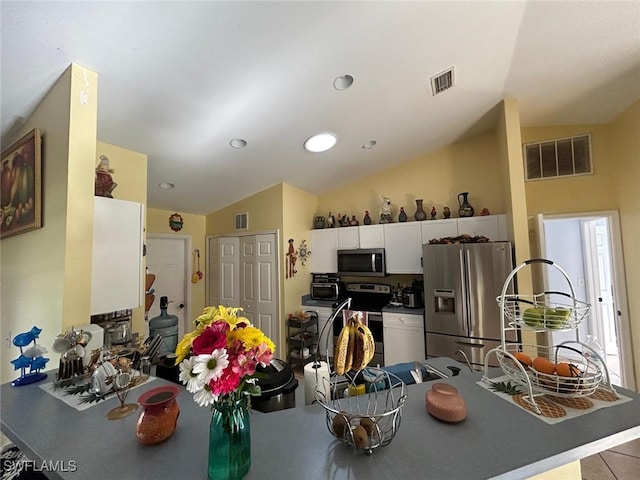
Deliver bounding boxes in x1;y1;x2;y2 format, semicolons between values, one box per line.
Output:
522;101;640;390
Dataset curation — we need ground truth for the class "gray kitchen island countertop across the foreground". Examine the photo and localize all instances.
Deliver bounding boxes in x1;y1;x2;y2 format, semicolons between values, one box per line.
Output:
1;359;640;480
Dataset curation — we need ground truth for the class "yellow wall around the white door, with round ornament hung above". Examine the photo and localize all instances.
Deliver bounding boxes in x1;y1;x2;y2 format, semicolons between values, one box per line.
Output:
142;208;207;332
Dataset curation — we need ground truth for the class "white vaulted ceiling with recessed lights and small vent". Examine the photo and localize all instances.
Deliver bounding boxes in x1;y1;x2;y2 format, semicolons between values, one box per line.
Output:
0;1;640;214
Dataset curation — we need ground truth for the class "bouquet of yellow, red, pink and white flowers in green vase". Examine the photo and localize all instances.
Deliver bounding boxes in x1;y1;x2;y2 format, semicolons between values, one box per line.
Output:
176;305;275;407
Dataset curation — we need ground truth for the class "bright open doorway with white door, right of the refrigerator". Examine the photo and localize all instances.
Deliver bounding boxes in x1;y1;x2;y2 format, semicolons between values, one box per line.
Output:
538;211;635;389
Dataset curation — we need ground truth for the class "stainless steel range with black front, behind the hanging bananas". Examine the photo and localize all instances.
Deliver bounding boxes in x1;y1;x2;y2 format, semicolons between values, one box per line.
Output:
333;283;391;366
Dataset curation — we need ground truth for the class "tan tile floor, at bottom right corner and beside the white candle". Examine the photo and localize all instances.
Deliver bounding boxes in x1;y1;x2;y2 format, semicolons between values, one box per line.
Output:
294;366;640;480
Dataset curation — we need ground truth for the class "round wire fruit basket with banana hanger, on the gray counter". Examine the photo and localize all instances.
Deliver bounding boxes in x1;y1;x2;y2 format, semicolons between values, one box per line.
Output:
315;299;407;455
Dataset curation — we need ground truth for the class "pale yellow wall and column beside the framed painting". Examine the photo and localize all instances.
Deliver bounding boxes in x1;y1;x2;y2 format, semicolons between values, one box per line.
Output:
0;65;98;382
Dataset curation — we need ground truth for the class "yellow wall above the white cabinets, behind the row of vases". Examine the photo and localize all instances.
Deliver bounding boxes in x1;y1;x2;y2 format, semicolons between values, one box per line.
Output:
318;131;508;222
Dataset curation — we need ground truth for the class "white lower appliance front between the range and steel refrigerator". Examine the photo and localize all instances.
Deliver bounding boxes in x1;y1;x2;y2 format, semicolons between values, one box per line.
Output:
382;311;427;366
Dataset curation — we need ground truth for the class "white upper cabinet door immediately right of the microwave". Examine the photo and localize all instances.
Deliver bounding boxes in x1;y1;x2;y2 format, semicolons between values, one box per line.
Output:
384;222;422;273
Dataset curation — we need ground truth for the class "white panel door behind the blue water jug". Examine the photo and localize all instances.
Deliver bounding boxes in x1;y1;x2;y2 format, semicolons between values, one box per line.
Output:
145;234;192;338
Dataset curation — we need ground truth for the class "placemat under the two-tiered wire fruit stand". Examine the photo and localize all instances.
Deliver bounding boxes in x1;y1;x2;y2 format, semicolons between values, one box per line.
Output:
476;375;631;425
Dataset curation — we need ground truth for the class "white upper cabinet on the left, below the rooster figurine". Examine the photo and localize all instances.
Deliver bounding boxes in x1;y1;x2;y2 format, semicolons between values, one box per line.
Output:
91;197;144;315
